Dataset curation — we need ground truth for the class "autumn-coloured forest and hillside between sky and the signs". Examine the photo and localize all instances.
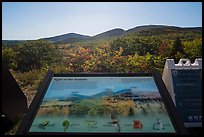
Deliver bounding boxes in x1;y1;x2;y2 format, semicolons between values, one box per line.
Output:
2;25;202;106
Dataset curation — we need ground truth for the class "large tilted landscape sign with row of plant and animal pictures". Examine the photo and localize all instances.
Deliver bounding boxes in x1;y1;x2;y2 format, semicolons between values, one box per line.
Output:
16;74;187;134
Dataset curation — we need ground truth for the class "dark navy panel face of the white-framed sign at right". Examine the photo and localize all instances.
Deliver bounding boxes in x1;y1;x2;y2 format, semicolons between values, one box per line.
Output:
171;69;202;126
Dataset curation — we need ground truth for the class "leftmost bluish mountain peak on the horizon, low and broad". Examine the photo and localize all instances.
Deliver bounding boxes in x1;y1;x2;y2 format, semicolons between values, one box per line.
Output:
42;33;90;43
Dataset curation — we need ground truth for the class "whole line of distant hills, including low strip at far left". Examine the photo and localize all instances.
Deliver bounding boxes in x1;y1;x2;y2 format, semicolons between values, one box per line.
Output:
2;25;202;46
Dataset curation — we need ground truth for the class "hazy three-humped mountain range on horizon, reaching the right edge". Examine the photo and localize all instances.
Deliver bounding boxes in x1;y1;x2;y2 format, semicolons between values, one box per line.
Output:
43;25;202;43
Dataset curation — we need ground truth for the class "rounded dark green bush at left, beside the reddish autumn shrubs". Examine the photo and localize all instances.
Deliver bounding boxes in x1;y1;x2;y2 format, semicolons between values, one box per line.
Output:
17;40;59;71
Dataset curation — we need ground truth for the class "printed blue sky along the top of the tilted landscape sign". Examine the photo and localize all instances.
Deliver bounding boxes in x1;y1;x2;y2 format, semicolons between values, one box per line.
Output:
45;77;158;98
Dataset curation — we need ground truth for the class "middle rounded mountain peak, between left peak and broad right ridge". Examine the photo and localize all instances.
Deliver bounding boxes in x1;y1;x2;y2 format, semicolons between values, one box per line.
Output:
91;28;125;39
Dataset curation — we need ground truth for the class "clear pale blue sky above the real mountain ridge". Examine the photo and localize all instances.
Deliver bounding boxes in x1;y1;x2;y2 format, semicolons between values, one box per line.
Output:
2;2;202;40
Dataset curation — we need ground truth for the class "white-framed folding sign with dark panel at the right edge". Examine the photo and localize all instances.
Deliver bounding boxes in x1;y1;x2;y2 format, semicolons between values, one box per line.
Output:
163;59;202;127
